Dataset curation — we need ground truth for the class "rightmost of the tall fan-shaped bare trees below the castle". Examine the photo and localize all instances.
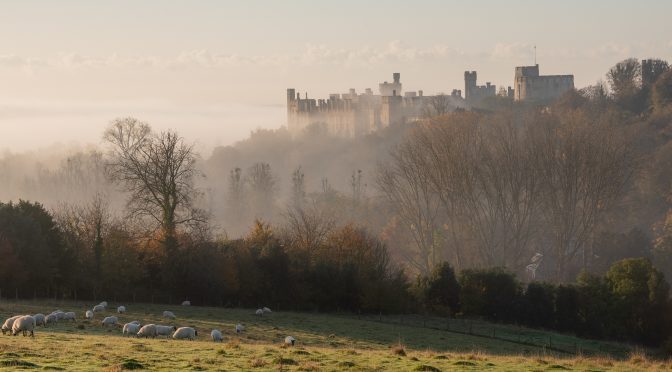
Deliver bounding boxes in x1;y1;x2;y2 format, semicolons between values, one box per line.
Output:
535;112;636;280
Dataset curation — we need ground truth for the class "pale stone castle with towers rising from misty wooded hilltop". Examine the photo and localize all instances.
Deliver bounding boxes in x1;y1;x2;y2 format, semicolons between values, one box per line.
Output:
287;65;574;138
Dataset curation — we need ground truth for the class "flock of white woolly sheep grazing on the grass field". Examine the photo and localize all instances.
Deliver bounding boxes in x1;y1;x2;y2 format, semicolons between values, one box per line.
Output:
2;301;296;346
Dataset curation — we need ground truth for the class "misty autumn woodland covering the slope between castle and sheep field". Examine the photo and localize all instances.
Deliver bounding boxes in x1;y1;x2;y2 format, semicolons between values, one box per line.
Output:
0;59;672;348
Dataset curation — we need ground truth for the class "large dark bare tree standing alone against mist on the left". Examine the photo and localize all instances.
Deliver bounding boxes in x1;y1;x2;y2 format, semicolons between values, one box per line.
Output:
104;118;206;249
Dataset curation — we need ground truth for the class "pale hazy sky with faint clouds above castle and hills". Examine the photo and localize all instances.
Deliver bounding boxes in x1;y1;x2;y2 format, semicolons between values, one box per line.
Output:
0;0;672;151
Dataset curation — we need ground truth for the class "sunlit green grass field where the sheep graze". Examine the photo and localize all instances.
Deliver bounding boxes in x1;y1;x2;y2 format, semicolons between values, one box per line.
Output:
0;301;672;371
